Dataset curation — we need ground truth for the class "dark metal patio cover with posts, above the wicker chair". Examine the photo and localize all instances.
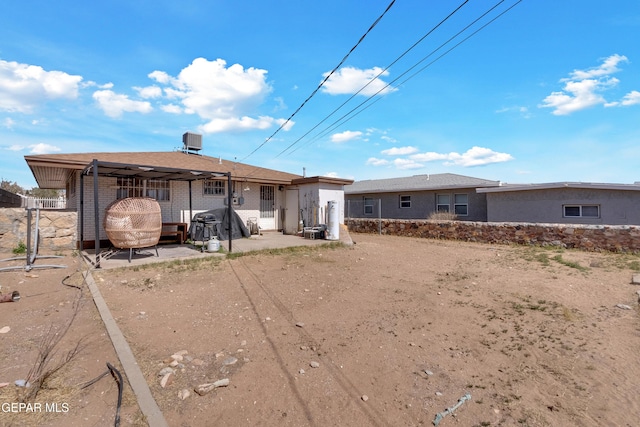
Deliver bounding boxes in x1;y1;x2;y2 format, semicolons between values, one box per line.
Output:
80;159;233;268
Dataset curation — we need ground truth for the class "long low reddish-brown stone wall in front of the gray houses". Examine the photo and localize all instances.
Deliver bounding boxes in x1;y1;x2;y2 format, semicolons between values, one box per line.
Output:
345;219;640;253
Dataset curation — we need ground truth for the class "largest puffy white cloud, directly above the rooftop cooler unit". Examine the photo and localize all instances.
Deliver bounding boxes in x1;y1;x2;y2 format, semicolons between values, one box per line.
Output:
148;58;286;133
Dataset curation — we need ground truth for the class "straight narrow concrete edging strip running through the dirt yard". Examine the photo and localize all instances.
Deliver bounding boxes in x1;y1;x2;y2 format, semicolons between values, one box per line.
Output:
83;271;169;427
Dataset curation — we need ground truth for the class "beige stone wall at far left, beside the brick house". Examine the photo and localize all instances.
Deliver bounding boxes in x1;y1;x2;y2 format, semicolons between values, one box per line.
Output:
0;208;78;252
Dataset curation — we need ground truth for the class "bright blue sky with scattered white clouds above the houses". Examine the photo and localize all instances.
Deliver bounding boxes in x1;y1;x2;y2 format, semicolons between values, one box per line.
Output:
0;0;640;188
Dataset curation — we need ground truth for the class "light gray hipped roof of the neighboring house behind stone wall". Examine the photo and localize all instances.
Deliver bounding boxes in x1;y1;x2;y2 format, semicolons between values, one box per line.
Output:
344;173;500;194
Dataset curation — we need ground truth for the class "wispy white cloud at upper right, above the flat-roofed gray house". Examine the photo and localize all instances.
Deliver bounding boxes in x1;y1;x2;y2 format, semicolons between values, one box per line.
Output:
539;54;636;116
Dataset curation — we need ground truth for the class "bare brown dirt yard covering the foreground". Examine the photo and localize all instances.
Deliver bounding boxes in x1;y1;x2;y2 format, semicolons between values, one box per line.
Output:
0;234;640;426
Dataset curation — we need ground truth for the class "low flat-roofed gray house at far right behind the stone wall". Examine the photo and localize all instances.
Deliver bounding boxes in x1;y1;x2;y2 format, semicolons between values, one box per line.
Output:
478;182;640;225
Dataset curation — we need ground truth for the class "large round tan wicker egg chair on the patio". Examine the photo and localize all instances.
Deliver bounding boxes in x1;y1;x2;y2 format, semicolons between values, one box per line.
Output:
102;197;162;254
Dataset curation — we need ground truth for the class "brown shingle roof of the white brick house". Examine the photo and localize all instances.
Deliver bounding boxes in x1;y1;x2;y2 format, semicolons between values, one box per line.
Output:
25;151;301;188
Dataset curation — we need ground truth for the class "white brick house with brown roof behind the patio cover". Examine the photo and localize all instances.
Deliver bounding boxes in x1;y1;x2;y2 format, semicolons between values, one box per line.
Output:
25;143;353;248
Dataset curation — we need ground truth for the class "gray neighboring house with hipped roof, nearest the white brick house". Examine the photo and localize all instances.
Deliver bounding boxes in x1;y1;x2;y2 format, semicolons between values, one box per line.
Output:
344;173;500;221
